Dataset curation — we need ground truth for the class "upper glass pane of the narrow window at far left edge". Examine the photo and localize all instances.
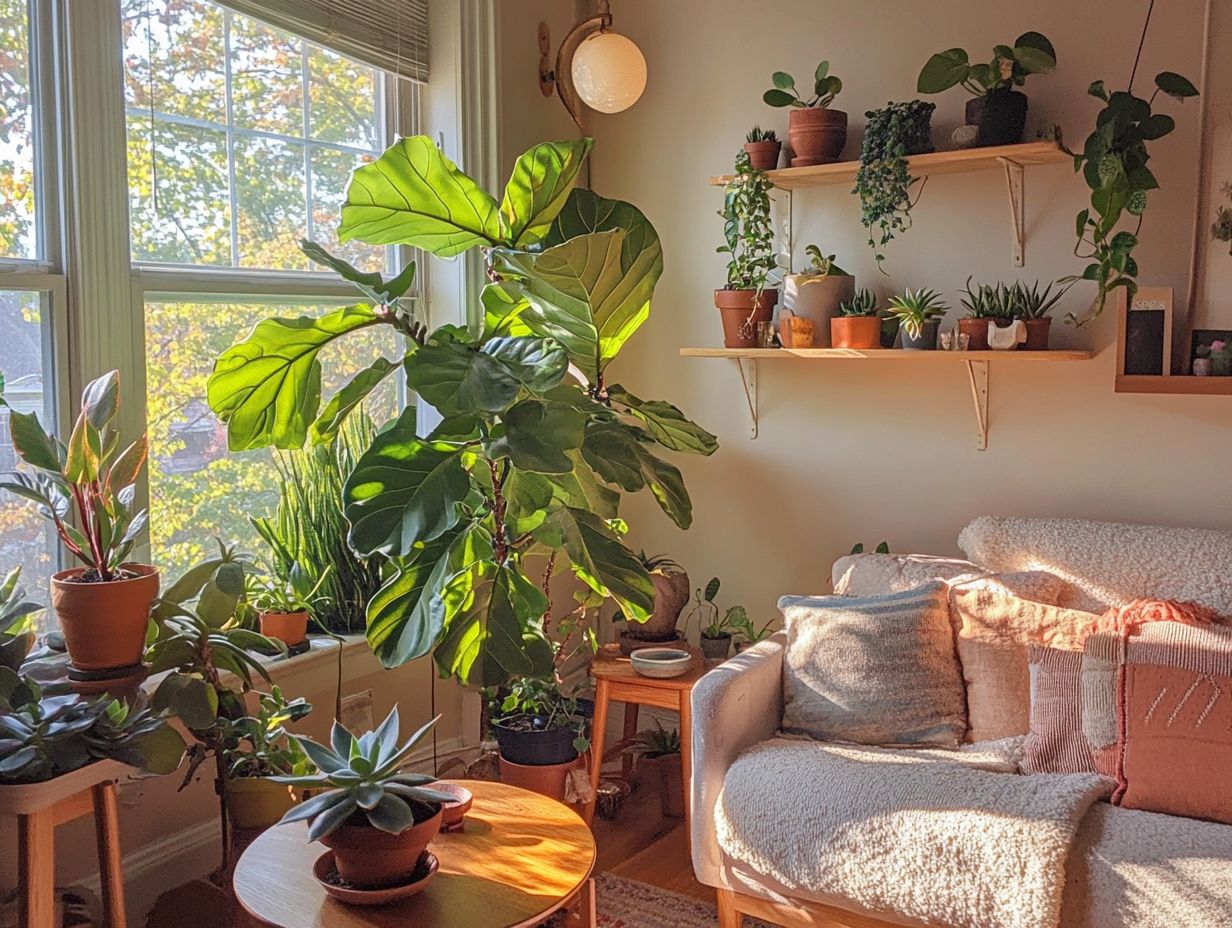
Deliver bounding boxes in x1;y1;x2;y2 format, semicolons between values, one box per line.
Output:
0;0;38;259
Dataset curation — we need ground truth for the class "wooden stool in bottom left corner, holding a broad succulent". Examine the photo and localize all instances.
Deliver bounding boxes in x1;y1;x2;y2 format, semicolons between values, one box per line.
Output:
0;760;133;928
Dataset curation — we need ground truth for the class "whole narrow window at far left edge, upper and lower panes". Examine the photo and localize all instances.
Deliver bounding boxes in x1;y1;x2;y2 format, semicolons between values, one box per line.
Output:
0;0;67;594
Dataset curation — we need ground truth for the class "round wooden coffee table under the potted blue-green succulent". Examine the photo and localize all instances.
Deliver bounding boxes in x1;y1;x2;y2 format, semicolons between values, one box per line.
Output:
234;780;595;928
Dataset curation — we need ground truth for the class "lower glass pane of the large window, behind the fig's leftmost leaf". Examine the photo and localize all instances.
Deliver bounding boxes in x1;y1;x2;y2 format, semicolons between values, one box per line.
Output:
145;301;400;577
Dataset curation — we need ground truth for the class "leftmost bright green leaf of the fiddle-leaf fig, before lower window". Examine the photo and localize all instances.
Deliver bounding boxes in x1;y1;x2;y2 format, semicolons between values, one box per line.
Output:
206;304;381;451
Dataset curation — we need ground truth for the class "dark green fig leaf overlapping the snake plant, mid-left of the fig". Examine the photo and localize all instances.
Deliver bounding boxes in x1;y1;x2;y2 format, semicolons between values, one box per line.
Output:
342;407;471;556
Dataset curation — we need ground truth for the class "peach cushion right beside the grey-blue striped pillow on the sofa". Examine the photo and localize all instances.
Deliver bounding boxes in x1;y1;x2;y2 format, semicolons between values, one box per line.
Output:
950;586;1099;741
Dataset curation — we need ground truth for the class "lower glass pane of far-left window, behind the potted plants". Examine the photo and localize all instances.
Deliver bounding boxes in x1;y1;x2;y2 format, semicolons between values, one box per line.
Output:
0;290;55;604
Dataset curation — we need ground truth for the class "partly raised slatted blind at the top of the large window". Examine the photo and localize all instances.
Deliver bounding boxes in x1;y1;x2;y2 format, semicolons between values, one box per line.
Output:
218;0;428;81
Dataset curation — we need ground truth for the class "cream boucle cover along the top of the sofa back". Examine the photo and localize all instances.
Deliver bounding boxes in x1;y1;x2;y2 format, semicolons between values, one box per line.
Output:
958;516;1232;616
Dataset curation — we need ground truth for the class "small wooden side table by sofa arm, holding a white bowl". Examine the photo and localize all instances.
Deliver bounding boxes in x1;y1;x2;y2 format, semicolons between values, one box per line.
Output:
585;645;707;832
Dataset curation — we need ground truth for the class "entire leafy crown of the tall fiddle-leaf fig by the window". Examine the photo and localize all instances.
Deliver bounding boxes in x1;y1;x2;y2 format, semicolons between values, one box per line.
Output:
208;136;717;685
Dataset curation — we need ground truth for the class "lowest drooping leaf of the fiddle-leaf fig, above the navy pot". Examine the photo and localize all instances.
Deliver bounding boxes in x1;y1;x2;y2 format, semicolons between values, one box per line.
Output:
434;561;547;686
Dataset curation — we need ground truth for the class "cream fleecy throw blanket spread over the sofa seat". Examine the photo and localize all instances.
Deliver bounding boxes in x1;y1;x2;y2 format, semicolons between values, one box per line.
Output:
716;738;1109;928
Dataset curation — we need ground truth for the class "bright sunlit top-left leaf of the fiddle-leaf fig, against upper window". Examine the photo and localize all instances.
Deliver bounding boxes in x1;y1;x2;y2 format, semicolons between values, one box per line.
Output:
338;136;501;258
